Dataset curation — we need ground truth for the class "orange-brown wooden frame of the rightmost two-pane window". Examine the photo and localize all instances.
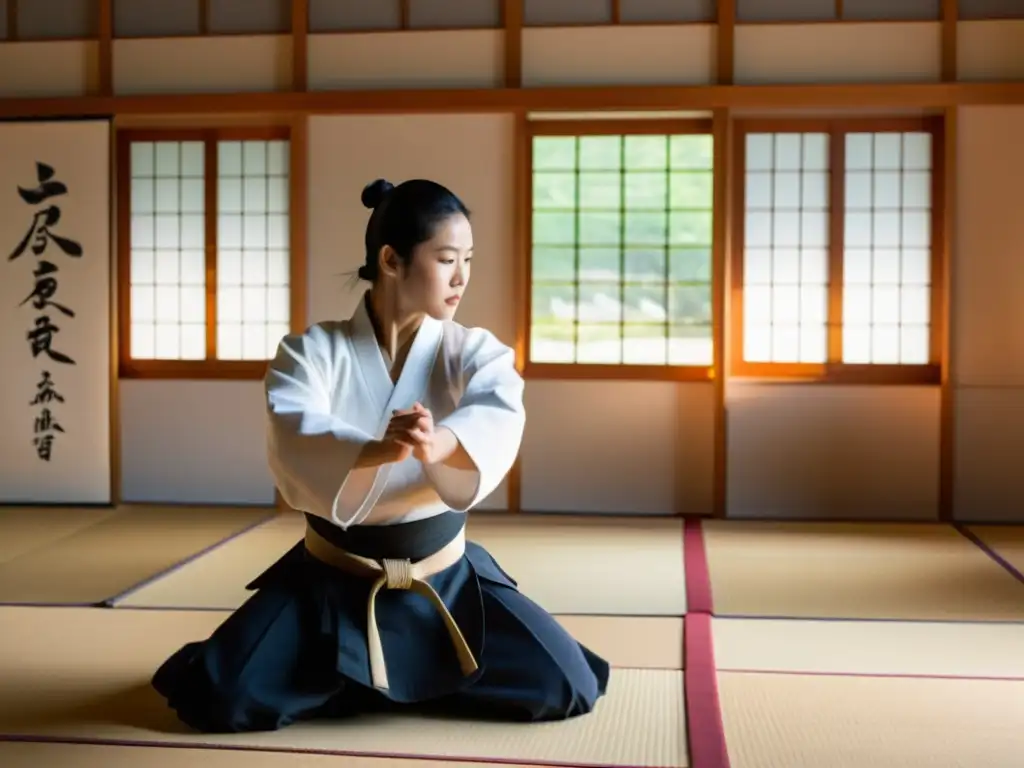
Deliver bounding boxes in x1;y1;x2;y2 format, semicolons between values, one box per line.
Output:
729;117;948;385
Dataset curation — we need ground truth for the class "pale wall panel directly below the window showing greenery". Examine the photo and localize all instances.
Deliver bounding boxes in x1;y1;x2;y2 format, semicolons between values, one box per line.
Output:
521;381;715;515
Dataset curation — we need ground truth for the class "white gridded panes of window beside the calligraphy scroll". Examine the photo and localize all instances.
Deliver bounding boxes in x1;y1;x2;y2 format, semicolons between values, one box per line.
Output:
129;139;291;360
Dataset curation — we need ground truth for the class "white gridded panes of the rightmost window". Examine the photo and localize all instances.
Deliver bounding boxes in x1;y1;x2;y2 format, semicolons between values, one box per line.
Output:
741;129;934;366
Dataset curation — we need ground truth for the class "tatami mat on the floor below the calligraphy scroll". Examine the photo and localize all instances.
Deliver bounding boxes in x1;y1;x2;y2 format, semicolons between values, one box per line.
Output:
0;507;269;605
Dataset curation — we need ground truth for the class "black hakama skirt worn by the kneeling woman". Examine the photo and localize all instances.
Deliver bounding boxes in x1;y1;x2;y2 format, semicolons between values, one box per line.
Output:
153;512;608;732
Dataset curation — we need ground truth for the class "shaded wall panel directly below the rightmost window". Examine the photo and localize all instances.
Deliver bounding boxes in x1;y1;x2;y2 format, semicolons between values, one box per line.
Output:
726;381;939;520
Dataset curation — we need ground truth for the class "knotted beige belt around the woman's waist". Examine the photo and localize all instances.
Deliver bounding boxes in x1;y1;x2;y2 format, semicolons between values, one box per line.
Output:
305;525;477;690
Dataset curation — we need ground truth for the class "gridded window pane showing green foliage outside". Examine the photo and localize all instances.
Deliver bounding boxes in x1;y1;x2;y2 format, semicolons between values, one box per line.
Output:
529;135;713;366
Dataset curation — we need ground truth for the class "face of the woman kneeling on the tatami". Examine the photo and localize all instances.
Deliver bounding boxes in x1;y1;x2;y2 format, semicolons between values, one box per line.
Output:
397;213;473;319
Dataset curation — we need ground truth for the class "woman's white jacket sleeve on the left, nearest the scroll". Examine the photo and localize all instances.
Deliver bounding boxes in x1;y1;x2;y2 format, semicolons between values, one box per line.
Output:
264;326;386;527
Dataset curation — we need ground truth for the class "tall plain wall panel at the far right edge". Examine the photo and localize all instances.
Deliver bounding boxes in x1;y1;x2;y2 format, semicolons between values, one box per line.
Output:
952;106;1024;520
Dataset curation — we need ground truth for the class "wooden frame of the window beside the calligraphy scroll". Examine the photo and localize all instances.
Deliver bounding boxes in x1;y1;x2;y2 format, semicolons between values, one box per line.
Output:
116;126;304;380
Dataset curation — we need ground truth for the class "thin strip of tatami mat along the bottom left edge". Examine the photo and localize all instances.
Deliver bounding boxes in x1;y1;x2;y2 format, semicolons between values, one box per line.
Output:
0;741;548;768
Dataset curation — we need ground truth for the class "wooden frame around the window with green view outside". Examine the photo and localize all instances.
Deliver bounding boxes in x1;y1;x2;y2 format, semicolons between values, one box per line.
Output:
521;119;722;382
